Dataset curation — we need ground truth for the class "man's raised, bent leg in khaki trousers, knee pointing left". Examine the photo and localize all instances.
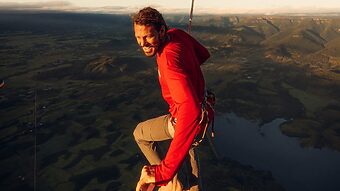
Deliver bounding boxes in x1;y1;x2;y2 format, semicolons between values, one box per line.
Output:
133;115;172;165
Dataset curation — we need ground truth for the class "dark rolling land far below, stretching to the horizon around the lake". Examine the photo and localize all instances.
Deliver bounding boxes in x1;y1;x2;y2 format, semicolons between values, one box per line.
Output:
0;12;340;191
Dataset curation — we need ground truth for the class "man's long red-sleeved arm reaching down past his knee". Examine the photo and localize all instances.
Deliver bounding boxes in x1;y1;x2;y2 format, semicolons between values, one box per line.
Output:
155;52;201;185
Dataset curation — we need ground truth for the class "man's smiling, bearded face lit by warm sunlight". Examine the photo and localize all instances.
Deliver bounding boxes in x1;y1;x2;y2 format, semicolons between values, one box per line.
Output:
134;24;165;57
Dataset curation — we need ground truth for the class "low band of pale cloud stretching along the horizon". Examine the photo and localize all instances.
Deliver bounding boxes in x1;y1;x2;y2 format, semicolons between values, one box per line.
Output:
0;0;340;15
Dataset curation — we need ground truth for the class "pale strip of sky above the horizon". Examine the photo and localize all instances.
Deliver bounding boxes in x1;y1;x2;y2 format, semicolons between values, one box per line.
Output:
0;0;340;14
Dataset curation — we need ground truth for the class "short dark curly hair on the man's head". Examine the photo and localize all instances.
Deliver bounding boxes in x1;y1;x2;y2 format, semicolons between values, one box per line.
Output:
132;7;168;31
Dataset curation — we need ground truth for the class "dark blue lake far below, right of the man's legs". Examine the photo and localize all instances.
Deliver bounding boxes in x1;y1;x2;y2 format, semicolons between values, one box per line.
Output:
215;113;340;191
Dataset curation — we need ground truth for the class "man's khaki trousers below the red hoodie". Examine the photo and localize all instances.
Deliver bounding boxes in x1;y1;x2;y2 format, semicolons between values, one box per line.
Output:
133;115;198;191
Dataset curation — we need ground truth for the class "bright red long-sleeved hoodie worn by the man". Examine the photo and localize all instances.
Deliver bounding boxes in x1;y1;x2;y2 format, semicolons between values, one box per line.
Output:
155;29;210;185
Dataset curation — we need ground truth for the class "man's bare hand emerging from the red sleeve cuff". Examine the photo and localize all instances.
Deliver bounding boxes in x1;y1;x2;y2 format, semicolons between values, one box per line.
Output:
136;166;156;191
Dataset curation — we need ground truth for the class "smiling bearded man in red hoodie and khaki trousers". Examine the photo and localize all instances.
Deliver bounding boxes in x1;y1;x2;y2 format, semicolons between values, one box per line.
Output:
133;7;210;191
